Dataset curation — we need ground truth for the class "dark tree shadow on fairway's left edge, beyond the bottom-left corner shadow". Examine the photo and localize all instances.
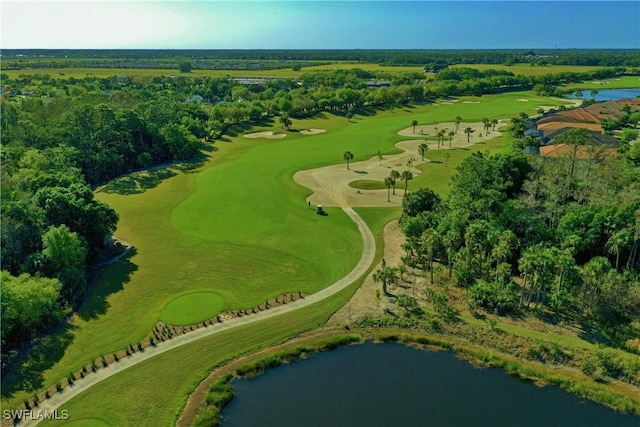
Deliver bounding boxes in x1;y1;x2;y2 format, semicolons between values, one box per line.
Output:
78;248;138;320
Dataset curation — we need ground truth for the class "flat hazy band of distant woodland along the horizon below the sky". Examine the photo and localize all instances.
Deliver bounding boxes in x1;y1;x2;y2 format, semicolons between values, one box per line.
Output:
2;49;640;70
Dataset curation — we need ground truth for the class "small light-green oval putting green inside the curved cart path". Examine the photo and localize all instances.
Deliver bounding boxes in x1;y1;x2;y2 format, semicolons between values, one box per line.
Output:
160;292;224;326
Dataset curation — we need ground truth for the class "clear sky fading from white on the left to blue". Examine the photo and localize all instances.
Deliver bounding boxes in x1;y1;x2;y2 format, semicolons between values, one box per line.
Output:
0;0;640;49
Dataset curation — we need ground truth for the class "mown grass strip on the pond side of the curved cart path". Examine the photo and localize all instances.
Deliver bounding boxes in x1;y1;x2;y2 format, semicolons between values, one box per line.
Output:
37;208;400;426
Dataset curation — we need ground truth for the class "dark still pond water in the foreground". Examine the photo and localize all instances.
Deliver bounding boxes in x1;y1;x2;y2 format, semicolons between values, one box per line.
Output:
221;343;640;427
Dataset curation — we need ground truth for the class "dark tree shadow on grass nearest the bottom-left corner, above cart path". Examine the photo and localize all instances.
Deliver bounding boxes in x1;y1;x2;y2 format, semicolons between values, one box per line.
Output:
2;324;75;398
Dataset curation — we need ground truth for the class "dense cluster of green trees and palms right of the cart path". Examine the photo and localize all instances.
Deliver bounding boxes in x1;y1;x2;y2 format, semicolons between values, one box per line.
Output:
400;144;640;346
